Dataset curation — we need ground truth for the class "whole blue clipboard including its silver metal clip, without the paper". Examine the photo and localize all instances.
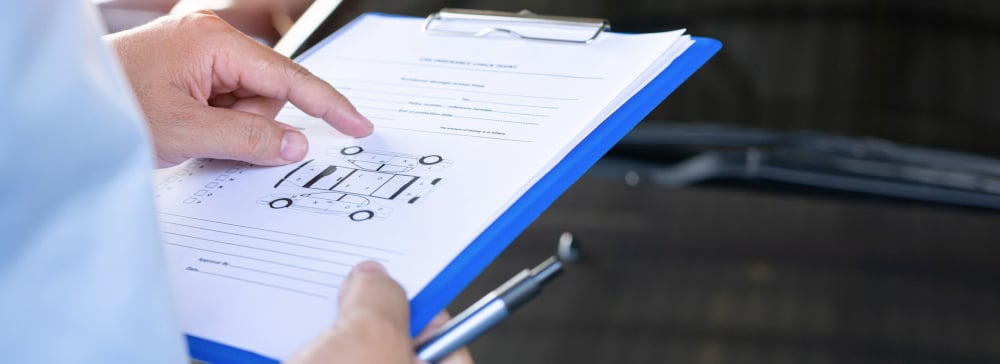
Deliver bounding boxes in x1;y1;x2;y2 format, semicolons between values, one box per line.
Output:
186;9;722;363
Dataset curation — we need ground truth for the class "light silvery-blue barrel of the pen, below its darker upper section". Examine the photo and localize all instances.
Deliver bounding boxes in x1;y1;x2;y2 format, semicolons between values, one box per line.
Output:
416;299;510;363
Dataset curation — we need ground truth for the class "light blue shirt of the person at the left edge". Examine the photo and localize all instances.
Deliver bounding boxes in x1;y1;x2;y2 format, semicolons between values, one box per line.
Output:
0;0;187;363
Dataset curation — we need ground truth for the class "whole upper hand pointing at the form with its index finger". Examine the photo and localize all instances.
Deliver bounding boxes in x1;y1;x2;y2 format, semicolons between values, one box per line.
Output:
107;11;372;167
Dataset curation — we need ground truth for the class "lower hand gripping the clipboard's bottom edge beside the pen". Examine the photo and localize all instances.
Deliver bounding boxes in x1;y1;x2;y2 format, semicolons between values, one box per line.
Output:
288;262;472;364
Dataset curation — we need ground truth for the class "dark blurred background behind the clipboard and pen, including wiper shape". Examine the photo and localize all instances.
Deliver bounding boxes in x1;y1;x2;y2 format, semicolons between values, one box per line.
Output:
105;0;1000;364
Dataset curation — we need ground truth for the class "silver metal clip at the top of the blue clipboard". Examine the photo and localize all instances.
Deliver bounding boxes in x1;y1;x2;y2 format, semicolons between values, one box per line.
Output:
423;8;611;44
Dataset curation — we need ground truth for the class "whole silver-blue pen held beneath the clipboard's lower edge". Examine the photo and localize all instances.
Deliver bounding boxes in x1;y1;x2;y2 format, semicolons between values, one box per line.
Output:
416;257;562;363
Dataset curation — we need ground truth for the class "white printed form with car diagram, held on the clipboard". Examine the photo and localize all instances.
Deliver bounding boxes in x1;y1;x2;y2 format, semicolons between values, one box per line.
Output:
156;15;691;360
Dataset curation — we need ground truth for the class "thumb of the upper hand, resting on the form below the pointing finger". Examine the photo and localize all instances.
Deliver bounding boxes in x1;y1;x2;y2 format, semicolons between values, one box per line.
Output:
153;107;309;165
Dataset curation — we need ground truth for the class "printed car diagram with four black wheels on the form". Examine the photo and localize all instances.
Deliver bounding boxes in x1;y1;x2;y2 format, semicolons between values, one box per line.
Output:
266;146;452;221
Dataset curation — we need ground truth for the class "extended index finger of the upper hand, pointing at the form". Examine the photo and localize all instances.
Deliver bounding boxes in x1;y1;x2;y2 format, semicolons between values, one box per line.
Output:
213;18;373;137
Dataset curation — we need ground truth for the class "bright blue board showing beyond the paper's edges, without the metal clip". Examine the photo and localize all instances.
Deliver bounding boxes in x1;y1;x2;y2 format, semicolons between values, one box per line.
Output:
186;14;722;363
